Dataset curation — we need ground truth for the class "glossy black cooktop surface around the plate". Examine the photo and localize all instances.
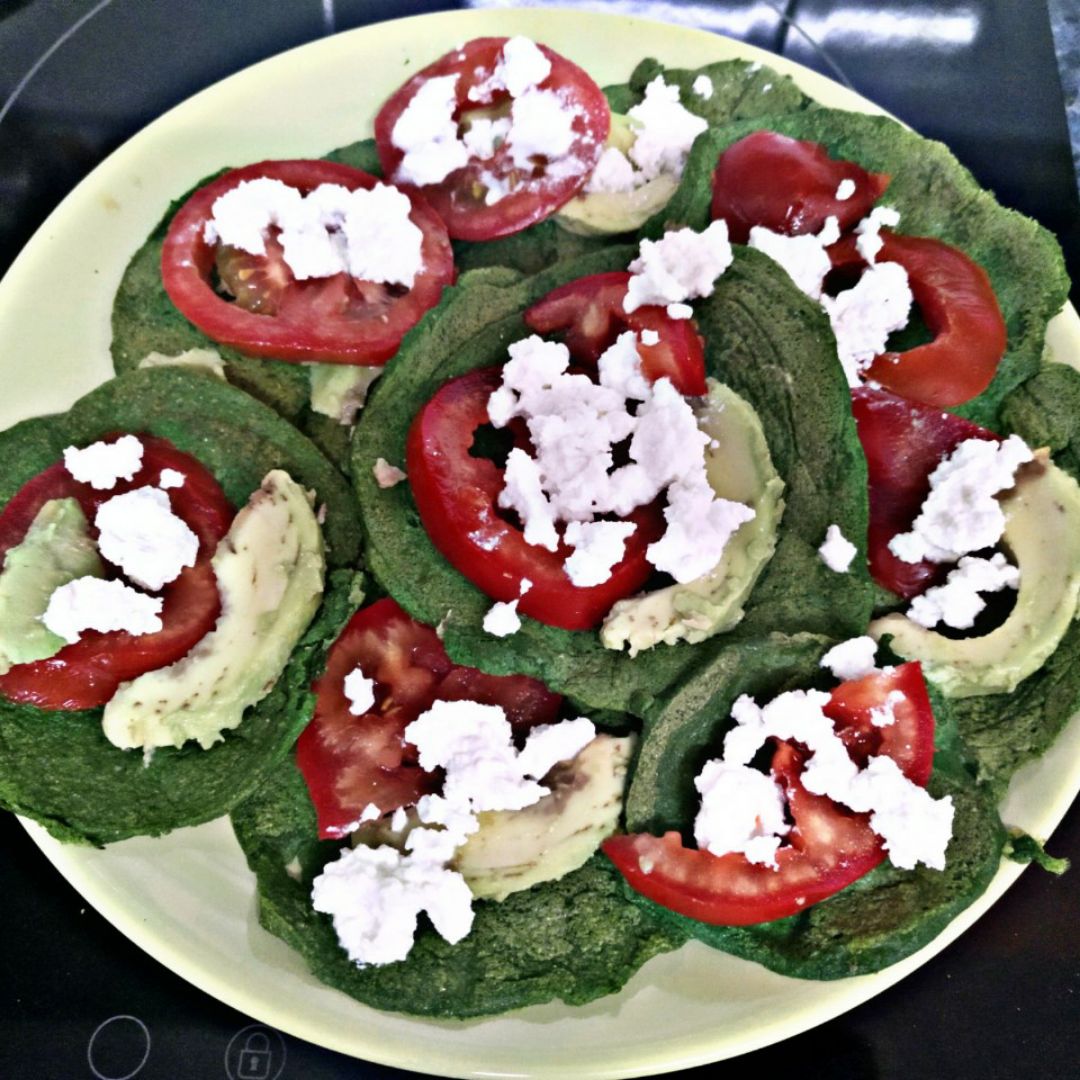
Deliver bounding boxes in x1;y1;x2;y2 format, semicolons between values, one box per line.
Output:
0;0;1080;1080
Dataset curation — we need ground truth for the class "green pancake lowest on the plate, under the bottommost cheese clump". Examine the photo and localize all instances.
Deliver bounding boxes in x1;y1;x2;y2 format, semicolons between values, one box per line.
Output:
232;760;686;1018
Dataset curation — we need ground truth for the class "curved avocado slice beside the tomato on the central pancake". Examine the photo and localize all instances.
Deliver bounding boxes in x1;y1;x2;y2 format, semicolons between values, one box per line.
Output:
600;379;784;657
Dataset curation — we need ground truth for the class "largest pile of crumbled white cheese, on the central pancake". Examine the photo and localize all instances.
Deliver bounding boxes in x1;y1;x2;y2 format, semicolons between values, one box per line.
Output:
488;332;754;583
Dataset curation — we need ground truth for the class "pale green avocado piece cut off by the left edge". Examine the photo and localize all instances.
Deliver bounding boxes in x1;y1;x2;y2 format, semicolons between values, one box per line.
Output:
0;499;105;675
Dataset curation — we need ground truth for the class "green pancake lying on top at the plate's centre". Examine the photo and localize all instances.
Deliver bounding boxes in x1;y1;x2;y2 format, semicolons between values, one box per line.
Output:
352;247;870;715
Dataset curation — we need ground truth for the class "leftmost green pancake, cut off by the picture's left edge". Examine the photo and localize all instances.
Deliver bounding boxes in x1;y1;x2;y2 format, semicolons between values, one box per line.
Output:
0;368;360;845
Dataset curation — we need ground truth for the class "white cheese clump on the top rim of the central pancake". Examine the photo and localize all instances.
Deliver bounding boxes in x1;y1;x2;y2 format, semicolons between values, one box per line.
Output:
622;220;733;312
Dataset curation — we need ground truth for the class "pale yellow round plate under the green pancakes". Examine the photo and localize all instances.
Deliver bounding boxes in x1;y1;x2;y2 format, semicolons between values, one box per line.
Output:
0;9;1080;1080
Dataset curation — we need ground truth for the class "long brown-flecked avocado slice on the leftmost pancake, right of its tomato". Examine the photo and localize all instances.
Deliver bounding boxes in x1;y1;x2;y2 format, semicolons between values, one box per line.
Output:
102;469;325;750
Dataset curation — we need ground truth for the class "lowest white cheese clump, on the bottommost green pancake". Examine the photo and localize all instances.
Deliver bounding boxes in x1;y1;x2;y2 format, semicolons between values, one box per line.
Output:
311;829;473;966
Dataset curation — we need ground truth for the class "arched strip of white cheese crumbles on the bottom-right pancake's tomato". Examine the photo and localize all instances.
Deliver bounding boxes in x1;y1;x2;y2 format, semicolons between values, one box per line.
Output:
710;690;954;869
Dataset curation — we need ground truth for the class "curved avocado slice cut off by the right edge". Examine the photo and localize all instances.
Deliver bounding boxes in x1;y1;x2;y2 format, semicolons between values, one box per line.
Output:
869;450;1080;698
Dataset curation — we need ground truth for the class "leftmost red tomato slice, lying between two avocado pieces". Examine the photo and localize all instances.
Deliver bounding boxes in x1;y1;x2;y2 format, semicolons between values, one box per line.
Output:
0;435;233;710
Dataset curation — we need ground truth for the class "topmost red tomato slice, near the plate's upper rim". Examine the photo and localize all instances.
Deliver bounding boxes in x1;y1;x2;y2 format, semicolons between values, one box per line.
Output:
375;38;611;240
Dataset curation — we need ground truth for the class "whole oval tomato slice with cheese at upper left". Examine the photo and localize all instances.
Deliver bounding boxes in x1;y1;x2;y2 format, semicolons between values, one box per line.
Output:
161;161;454;365
